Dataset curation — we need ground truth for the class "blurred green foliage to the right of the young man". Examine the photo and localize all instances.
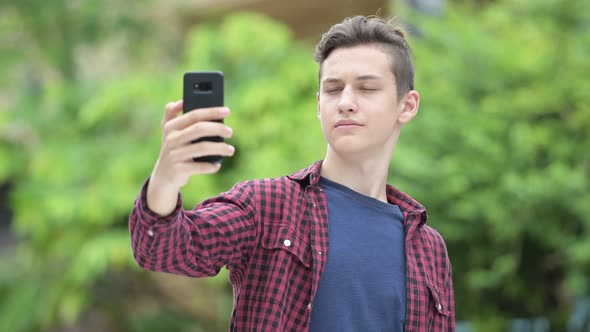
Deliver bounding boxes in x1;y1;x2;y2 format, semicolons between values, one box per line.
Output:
400;0;590;331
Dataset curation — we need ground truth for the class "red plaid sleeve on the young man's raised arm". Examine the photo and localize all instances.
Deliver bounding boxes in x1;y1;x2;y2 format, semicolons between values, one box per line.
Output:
129;179;257;277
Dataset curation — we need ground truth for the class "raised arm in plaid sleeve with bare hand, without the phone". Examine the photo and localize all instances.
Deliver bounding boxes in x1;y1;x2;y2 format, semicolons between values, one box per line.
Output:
129;101;256;277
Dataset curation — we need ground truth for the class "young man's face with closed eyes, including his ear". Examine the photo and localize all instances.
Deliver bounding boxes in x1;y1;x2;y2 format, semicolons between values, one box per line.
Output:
318;45;419;158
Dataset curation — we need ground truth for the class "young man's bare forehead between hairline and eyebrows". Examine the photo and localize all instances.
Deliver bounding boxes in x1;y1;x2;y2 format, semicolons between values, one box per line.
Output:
320;45;393;78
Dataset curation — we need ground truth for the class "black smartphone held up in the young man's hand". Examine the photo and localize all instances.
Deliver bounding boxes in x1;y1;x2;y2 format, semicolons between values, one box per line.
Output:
182;71;223;163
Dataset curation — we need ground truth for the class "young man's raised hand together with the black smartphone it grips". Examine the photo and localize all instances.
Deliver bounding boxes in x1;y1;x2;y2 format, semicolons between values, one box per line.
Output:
147;73;235;216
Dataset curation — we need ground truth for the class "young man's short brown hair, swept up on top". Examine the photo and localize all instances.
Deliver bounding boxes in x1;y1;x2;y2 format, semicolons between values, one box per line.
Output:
314;16;414;98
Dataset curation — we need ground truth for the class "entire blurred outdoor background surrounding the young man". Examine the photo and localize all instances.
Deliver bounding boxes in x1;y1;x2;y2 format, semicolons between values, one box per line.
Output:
0;0;590;332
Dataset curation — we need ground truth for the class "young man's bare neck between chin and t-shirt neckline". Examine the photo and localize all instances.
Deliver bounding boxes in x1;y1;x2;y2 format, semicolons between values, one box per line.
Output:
320;147;391;203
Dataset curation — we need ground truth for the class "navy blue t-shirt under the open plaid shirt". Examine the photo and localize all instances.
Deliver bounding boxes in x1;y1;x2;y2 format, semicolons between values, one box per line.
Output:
309;178;406;332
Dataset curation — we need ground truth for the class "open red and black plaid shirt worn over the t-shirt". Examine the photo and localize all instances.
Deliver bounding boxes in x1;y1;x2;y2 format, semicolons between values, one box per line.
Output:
129;161;455;332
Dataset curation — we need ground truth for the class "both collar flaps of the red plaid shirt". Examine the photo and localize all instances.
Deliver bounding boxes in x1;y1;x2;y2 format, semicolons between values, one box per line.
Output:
288;160;428;227
